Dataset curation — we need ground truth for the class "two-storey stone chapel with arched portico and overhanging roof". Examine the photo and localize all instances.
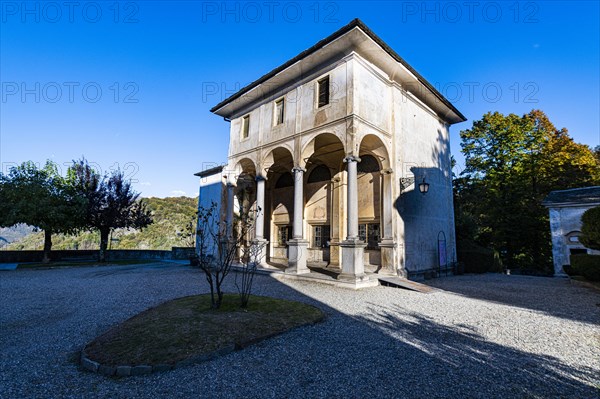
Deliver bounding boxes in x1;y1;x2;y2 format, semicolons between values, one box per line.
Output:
197;19;466;287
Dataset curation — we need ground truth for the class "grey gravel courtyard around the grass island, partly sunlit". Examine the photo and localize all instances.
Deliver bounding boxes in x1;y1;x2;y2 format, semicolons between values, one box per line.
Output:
0;264;600;398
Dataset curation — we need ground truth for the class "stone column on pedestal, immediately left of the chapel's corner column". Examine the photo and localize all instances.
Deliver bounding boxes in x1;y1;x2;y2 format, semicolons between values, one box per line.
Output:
286;166;310;274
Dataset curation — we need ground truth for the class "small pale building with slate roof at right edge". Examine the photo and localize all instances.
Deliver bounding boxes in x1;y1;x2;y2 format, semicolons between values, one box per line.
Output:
542;186;600;276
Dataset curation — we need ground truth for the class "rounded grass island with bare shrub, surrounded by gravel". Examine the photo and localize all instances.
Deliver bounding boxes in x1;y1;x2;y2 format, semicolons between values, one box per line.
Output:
85;294;325;366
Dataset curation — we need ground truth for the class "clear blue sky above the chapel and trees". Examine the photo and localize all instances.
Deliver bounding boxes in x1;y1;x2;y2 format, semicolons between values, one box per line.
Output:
0;0;600;197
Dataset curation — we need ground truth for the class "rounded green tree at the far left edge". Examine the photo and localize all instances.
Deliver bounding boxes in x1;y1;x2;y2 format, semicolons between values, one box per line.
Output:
0;161;85;263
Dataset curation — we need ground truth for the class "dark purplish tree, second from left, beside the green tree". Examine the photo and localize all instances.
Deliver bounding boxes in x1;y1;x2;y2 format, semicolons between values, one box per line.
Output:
68;160;152;262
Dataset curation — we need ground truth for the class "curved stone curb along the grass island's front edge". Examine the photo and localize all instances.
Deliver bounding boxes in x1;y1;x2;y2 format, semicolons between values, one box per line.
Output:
79;344;237;377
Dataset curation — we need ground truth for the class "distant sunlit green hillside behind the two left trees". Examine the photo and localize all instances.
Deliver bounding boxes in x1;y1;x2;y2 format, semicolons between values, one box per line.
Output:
5;197;198;250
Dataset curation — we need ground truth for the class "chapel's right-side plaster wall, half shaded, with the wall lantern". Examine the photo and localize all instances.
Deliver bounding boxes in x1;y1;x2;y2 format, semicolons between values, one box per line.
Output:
394;87;456;274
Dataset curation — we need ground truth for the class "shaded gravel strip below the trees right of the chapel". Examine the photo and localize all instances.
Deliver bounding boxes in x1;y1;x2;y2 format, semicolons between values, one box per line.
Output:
427;273;600;325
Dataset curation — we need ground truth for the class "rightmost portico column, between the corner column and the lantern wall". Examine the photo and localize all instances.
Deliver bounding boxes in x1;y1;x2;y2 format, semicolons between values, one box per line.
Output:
379;169;398;275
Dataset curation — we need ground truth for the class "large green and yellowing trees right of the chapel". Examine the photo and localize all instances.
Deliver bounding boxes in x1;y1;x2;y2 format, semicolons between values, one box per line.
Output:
454;110;600;271
